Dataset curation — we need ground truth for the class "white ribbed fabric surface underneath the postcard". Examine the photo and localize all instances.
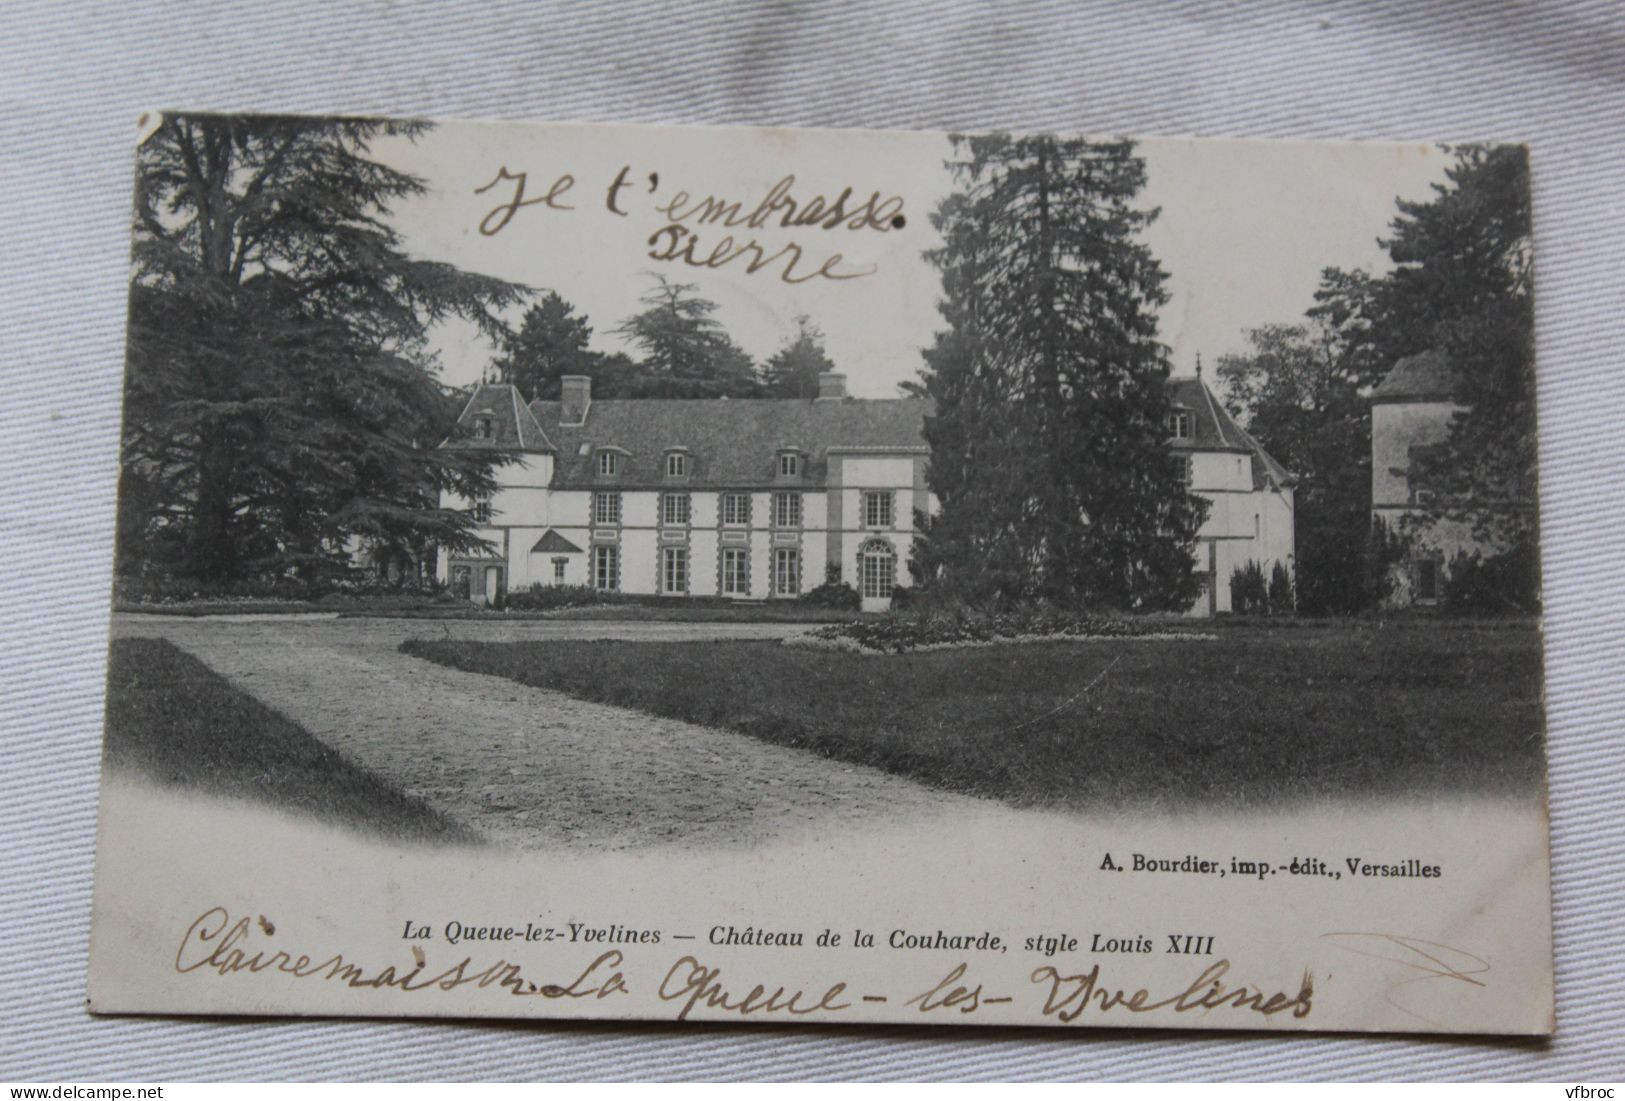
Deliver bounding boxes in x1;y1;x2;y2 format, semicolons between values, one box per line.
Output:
0;0;1625;1082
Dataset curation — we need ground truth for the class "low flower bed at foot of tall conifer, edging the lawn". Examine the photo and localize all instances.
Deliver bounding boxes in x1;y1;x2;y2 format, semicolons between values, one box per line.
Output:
785;607;1211;654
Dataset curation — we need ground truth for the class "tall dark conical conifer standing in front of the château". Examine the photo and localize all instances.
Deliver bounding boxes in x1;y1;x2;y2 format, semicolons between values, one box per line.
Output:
913;135;1206;609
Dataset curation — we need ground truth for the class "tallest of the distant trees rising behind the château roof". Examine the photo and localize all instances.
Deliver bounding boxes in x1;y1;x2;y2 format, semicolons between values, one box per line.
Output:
616;274;761;398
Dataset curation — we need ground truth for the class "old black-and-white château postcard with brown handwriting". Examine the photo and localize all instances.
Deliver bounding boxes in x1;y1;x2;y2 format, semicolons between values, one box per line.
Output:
89;112;1554;1034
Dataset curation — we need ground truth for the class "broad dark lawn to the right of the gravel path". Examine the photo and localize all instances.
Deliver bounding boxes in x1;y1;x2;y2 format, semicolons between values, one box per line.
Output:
403;624;1544;809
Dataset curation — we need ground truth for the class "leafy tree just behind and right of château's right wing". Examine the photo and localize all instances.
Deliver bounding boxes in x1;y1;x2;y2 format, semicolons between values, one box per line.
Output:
1217;318;1373;615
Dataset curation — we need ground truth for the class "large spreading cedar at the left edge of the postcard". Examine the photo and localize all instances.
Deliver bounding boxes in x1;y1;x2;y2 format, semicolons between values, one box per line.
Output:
120;115;527;580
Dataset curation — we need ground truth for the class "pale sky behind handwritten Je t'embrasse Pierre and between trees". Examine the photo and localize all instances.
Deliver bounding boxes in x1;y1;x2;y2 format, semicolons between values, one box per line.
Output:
377;123;1450;398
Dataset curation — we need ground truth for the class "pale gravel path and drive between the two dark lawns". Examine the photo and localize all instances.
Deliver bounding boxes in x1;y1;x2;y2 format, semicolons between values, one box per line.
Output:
114;615;985;849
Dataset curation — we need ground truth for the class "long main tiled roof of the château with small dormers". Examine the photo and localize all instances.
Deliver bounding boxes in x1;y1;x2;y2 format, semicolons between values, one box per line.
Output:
530;398;931;489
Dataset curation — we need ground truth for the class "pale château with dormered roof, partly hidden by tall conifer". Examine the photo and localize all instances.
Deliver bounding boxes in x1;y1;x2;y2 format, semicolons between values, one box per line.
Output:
439;373;1294;614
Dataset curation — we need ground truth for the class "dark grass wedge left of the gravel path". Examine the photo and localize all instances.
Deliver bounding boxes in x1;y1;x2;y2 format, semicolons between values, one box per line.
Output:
102;638;479;841
